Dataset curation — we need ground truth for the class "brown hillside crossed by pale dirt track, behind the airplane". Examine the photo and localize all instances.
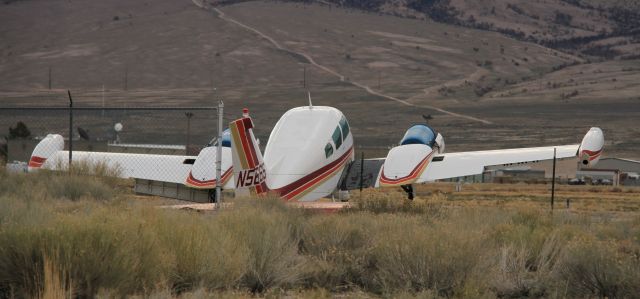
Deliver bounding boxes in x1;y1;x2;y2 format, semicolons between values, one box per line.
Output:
0;0;640;158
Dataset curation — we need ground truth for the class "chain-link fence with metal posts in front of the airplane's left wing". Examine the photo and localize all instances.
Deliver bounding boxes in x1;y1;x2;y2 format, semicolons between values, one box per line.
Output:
0;97;229;201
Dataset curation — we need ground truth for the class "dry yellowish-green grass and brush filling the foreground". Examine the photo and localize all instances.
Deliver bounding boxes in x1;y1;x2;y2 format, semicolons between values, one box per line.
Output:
0;172;640;298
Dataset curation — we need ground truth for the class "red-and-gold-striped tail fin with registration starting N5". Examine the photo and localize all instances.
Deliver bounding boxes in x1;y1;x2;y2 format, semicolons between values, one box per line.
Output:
229;108;269;196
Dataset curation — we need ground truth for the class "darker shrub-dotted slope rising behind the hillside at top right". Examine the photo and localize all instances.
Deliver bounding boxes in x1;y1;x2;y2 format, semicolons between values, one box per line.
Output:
274;0;640;59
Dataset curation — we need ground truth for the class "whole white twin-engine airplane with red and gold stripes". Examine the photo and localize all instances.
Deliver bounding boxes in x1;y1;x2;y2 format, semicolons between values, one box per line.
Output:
29;104;604;202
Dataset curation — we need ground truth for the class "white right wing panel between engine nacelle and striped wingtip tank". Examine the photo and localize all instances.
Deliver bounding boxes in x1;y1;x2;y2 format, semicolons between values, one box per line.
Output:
416;144;580;183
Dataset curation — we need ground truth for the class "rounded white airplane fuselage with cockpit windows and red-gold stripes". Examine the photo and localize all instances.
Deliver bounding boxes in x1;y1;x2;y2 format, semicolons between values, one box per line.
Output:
264;106;354;201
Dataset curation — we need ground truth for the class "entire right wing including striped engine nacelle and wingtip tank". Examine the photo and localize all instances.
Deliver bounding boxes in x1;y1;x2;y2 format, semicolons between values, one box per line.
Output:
340;128;604;190
